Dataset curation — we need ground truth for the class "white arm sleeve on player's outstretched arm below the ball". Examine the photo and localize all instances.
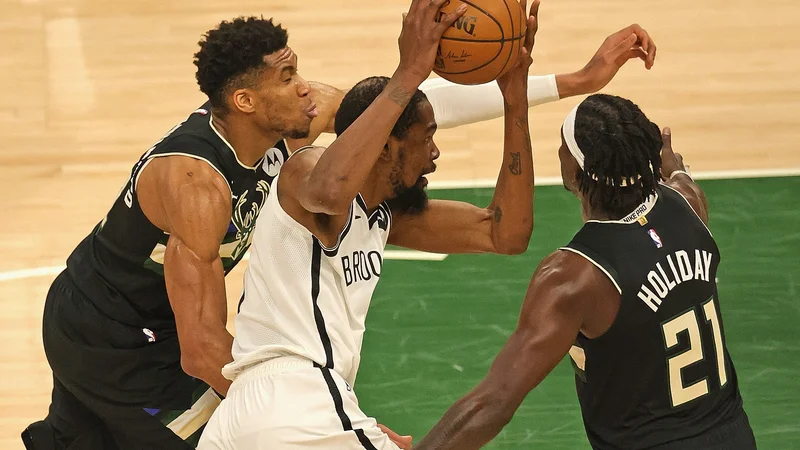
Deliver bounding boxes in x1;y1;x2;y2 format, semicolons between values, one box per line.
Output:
419;75;559;129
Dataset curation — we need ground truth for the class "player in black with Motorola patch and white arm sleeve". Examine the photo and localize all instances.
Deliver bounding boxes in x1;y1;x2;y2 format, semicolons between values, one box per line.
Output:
23;7;664;450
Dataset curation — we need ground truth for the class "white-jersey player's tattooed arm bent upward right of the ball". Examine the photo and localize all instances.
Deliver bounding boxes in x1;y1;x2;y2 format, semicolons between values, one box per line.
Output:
389;0;539;254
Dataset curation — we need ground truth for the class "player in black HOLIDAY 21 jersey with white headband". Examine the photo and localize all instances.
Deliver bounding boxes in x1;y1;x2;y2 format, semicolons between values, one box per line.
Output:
414;95;756;450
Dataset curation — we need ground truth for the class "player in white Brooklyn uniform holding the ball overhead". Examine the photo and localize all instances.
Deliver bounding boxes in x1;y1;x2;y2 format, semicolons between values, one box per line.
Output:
198;0;538;450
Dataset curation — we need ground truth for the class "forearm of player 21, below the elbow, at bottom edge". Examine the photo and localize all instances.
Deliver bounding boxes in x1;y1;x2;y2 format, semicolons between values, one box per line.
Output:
414;391;509;450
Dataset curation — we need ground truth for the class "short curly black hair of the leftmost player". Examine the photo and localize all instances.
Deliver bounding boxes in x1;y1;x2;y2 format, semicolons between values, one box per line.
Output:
194;16;289;109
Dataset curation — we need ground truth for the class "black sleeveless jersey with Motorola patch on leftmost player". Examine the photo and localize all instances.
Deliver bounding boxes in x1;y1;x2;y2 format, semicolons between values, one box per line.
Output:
67;103;288;330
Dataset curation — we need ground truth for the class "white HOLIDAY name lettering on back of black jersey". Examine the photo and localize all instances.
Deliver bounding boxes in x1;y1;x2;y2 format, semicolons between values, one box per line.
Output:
638;250;713;311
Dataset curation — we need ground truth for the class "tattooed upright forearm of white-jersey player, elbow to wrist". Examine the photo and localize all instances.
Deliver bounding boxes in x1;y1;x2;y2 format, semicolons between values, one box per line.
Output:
489;104;534;253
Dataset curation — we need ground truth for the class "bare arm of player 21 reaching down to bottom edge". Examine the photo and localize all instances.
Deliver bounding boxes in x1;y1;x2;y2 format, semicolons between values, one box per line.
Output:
414;251;619;450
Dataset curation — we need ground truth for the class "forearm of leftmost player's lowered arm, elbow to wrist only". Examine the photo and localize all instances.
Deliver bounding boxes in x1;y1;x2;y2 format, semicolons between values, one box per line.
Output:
164;253;233;395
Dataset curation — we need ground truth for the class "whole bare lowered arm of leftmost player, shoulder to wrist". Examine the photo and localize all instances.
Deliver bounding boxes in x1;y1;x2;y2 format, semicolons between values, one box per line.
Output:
137;156;233;395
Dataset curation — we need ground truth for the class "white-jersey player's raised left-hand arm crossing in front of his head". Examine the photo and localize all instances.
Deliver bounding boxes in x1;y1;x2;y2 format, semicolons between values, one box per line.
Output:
279;0;466;215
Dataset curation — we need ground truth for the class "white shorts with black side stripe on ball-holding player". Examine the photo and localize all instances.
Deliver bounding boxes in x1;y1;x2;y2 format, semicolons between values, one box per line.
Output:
197;357;399;450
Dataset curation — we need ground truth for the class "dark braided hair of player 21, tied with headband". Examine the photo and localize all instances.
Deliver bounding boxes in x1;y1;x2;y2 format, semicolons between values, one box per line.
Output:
575;94;662;217
